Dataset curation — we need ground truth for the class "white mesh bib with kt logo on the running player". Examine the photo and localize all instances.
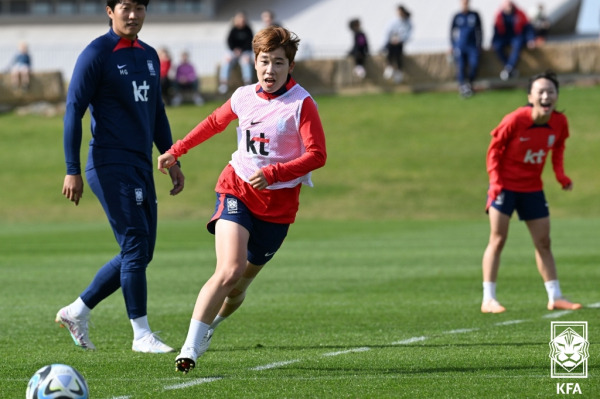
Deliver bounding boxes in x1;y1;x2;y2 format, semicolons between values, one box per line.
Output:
229;84;313;190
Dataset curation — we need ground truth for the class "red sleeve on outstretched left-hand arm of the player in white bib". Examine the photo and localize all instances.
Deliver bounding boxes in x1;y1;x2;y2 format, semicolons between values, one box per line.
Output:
167;99;237;158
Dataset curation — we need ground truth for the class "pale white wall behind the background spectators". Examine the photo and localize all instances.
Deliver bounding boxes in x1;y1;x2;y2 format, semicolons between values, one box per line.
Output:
0;0;600;80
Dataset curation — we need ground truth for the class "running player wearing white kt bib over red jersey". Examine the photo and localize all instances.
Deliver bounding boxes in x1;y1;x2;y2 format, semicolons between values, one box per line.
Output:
158;26;327;373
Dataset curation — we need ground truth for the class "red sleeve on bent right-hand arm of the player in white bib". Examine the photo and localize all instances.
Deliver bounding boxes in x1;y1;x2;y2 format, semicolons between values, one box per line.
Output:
262;97;327;184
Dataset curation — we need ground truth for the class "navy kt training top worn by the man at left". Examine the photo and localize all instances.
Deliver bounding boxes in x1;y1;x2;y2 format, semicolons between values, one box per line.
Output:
64;28;173;175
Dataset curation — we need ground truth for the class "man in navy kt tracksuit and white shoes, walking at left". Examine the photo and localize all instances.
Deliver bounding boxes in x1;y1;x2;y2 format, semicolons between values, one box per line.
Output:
56;0;184;353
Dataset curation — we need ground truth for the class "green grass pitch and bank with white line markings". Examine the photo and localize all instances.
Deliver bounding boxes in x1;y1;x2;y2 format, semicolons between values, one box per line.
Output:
0;87;600;399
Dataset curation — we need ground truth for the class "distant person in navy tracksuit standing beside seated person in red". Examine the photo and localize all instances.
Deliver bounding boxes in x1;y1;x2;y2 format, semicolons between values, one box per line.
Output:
450;0;482;97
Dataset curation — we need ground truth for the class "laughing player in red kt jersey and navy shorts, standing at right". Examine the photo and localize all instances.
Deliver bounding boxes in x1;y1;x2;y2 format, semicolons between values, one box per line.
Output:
481;72;581;313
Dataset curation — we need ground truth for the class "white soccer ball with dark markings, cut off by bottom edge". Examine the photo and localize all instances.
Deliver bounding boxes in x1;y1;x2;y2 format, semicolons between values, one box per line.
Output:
25;364;88;399
